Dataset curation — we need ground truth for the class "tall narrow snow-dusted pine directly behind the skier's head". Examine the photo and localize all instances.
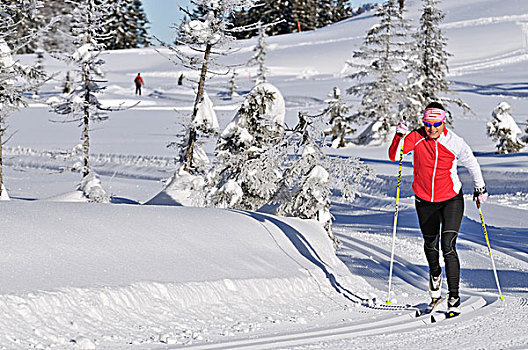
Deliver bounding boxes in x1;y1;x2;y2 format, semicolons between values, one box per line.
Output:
401;0;469;128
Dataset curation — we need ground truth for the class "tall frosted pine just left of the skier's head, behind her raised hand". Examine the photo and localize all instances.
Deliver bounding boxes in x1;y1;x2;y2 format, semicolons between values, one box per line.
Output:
347;0;410;144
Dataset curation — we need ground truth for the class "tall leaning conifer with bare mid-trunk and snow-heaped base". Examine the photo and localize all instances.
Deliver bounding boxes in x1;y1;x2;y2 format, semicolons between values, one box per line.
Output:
146;0;253;206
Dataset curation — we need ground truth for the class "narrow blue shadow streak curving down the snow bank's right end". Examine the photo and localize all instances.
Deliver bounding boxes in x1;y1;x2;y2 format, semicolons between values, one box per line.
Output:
234;210;367;303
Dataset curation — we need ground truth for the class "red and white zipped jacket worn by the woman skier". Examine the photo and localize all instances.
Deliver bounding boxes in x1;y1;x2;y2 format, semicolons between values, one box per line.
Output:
389;127;484;202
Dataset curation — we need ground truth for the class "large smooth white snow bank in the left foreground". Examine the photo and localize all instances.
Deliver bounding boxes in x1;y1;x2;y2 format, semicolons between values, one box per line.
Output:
0;201;371;348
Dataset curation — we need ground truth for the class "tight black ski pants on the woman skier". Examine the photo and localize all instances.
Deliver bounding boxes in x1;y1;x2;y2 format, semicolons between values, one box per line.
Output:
415;191;464;297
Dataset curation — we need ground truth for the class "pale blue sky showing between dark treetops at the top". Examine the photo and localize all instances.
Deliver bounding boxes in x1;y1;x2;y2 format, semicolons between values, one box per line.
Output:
142;0;375;42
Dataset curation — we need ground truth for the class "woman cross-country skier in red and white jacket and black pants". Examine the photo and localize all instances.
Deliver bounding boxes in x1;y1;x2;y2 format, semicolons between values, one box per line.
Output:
389;102;488;316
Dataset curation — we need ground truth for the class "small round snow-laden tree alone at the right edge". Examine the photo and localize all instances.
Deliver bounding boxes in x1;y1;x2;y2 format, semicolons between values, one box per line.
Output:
486;102;526;154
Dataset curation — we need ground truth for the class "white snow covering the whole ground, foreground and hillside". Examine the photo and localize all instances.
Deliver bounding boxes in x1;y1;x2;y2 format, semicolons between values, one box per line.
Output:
0;0;528;349
